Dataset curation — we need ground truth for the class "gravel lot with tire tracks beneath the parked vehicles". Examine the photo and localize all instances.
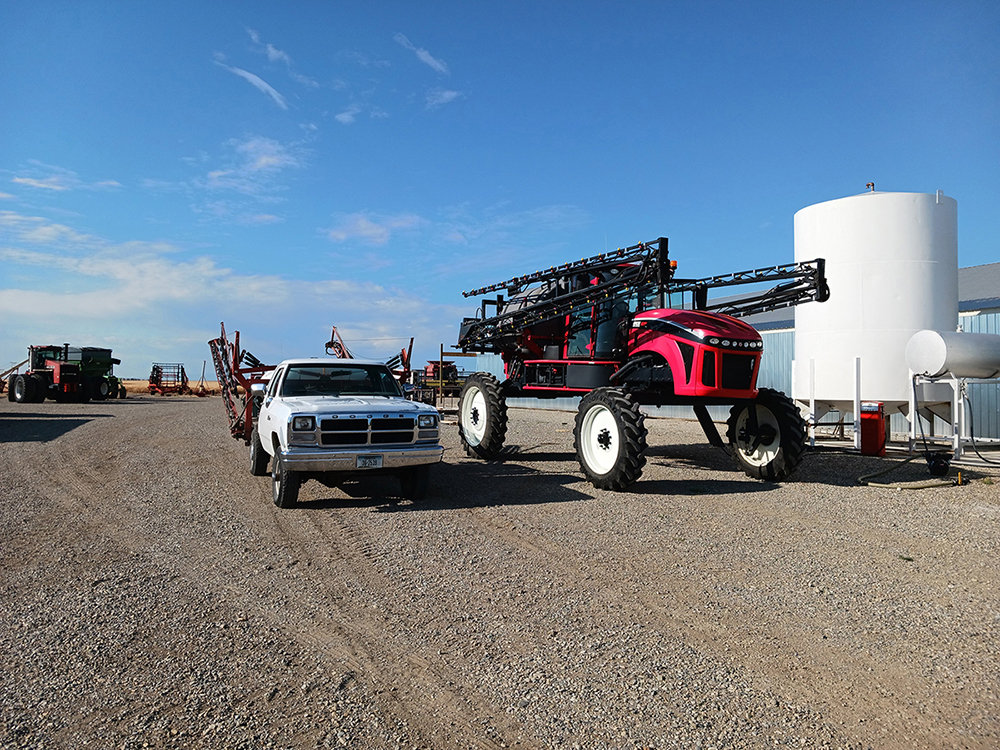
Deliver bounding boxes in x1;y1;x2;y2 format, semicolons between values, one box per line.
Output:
0;397;1000;748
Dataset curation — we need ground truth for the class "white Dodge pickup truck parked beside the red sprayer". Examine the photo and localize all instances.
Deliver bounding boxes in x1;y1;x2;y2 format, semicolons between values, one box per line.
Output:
250;358;444;508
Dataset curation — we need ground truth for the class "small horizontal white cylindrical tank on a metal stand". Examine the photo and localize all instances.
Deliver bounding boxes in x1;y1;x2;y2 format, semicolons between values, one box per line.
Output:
906;331;1000;378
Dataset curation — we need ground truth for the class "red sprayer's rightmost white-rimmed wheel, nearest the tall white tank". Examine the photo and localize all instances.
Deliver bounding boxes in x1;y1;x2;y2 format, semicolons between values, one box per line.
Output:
726;388;806;482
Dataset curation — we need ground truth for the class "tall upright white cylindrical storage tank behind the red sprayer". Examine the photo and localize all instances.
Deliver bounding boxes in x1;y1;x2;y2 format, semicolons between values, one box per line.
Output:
792;191;958;417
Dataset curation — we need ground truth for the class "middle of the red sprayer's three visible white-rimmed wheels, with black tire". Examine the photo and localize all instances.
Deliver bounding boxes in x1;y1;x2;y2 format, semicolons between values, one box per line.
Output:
573;388;646;490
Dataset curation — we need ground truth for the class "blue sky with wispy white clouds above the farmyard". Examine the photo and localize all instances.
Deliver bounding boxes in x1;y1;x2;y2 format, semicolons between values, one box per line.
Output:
0;0;1000;377
